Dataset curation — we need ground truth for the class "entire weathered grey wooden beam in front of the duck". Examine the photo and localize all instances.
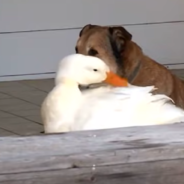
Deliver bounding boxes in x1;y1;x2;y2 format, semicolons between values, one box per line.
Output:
0;123;184;184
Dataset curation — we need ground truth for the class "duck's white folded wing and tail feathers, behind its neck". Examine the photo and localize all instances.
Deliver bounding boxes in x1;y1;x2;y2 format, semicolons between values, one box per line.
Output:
76;86;184;130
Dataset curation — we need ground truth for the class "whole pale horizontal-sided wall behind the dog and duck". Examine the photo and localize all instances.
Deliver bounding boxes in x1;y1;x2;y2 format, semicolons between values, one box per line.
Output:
0;0;184;80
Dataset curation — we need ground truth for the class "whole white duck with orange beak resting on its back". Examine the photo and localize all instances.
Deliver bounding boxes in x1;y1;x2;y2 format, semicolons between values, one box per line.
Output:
41;54;184;133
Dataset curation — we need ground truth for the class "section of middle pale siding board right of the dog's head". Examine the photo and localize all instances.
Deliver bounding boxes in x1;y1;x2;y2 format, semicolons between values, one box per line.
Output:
126;23;184;64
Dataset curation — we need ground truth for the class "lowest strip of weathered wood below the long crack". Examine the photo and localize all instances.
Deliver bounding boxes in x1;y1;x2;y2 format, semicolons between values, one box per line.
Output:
0;160;184;184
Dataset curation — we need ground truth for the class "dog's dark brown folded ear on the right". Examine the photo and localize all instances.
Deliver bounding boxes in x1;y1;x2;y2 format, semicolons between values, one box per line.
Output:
109;26;132;51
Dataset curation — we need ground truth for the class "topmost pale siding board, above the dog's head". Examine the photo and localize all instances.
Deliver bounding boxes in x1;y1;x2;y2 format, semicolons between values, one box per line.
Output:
0;0;184;32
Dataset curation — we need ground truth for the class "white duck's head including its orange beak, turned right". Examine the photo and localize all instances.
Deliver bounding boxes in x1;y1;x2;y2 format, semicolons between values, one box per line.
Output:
55;54;128;86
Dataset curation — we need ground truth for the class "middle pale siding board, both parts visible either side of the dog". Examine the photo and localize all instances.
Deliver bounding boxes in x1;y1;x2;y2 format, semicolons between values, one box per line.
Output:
0;23;184;80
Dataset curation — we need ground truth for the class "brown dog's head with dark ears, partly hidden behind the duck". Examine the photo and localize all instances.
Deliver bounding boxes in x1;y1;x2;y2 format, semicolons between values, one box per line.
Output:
75;24;132;73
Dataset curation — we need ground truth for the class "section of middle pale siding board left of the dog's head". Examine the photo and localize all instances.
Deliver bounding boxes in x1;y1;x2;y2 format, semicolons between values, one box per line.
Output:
0;30;79;77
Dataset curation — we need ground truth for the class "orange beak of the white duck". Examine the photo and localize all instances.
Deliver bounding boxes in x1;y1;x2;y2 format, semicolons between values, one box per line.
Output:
104;71;128;87
